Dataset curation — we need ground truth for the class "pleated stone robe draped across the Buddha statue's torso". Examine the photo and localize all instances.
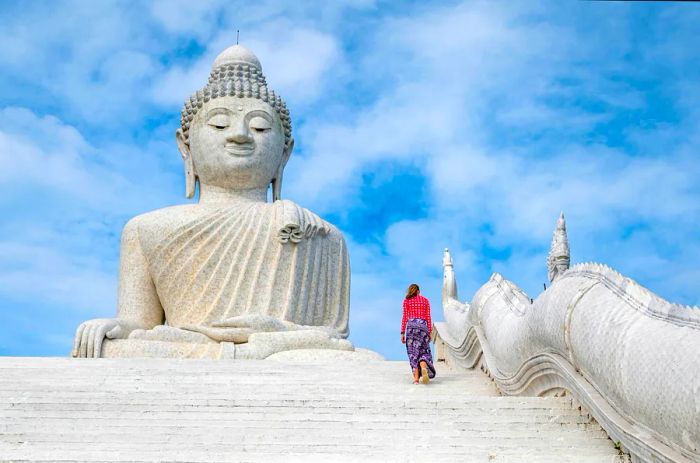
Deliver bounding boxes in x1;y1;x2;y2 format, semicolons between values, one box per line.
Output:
132;200;350;338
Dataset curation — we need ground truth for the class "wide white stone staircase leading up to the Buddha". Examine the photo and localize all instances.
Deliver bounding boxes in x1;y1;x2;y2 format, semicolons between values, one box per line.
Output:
0;357;627;463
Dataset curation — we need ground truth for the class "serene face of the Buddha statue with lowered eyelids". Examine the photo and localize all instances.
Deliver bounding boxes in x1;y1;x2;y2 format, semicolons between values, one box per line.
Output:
178;96;291;190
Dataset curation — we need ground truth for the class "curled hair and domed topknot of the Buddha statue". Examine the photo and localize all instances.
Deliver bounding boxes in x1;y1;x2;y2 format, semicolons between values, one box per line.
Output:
180;45;292;148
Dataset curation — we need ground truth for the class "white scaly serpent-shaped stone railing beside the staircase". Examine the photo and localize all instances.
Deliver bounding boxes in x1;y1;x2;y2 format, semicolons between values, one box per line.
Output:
436;250;700;462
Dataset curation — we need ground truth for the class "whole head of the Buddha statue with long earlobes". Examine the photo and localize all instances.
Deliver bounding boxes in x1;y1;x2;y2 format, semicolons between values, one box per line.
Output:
176;45;294;201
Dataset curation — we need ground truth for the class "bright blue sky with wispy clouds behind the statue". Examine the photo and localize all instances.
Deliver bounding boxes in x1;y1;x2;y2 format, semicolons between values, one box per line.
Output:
0;0;700;359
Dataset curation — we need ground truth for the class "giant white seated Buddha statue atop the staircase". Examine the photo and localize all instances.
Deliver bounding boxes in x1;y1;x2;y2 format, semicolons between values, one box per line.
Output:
72;45;353;358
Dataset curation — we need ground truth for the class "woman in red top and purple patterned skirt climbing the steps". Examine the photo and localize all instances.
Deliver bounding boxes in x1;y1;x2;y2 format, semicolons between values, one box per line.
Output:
401;283;435;384
